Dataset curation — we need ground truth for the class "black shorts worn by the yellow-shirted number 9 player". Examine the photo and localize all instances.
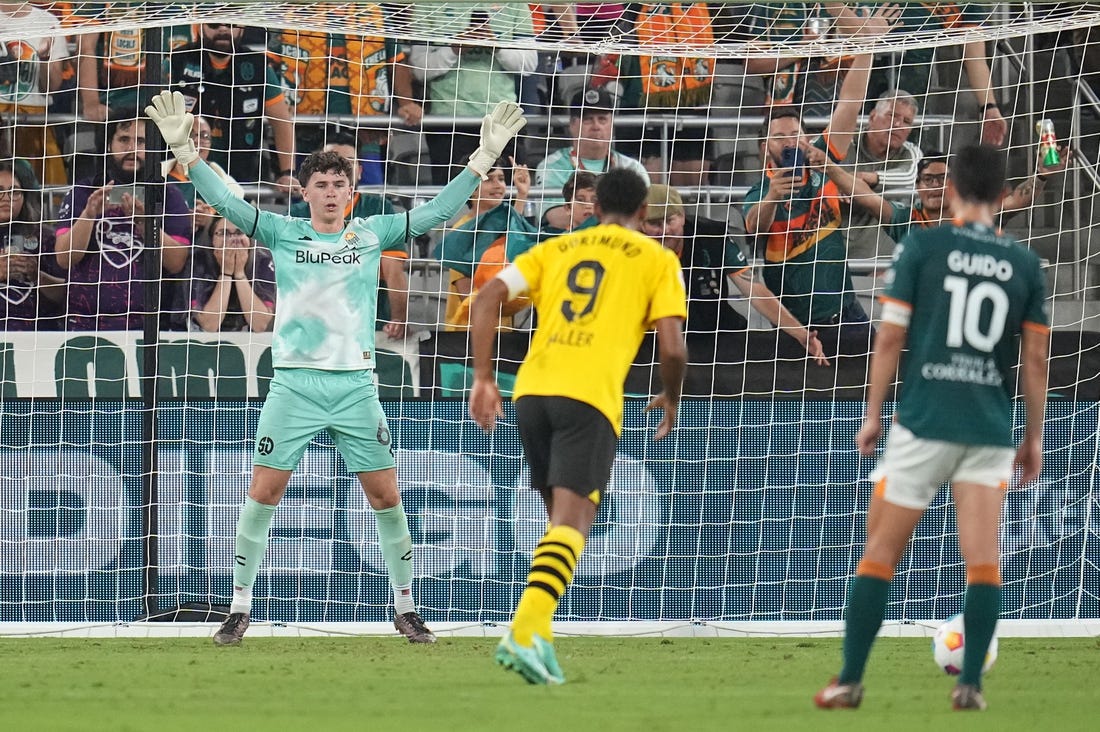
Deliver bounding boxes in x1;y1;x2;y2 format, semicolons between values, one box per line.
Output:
516;396;618;505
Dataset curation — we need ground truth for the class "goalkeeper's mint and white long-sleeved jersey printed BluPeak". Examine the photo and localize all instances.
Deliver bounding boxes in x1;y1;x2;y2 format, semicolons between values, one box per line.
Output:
190;162;479;371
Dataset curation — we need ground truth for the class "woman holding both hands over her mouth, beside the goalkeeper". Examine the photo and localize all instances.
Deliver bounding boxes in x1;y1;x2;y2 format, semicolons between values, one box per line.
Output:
190;216;275;332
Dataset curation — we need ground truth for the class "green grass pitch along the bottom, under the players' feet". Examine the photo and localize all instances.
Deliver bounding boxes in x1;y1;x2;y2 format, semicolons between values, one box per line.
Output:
0;637;1100;732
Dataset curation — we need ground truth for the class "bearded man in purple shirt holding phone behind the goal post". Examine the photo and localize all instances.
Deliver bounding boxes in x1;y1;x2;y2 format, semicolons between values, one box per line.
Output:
56;110;191;330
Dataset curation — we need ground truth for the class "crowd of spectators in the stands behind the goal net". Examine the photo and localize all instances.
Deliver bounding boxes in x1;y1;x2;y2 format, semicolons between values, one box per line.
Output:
0;2;1071;345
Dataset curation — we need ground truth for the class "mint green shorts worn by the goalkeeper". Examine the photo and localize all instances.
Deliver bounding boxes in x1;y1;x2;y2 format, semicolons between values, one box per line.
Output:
252;369;395;473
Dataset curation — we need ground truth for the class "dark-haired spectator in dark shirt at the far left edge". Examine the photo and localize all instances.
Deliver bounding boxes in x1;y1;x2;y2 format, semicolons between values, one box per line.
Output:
0;161;65;330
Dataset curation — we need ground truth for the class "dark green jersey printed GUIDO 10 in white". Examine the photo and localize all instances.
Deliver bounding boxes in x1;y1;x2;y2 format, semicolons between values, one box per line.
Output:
883;223;1048;447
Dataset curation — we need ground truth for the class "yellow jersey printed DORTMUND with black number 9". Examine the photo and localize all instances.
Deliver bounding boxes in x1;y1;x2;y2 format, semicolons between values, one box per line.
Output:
514;223;688;435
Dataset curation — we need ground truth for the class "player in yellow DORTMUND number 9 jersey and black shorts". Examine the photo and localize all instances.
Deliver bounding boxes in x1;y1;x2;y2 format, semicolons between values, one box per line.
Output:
470;168;688;684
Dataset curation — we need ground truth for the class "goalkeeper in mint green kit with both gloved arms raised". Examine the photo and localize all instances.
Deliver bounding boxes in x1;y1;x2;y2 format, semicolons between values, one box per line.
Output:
145;91;526;645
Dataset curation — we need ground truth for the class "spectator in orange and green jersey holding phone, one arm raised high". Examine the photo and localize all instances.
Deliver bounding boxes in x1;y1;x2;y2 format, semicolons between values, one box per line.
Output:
744;6;899;357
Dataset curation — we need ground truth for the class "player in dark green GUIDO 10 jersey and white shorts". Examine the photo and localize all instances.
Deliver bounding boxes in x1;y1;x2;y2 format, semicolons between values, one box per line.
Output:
814;146;1049;709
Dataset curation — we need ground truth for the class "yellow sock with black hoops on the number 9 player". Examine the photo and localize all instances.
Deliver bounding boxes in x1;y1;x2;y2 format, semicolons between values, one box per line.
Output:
512;526;584;646
